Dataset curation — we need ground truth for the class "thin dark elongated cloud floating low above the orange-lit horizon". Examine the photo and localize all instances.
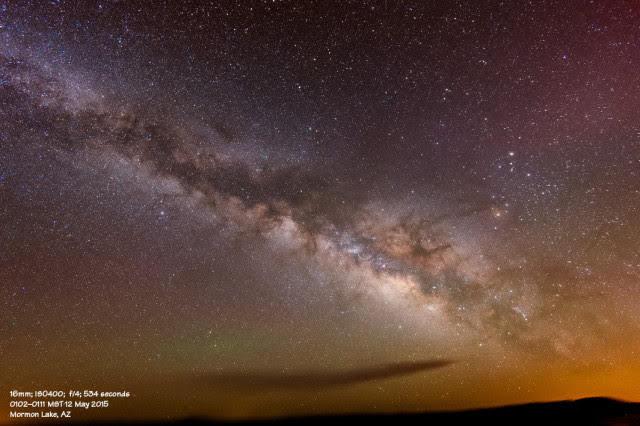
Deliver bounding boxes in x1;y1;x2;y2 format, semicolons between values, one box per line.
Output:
196;360;454;390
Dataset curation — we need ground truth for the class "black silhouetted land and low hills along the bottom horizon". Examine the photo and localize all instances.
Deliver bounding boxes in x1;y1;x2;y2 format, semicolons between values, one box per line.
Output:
32;398;640;426
